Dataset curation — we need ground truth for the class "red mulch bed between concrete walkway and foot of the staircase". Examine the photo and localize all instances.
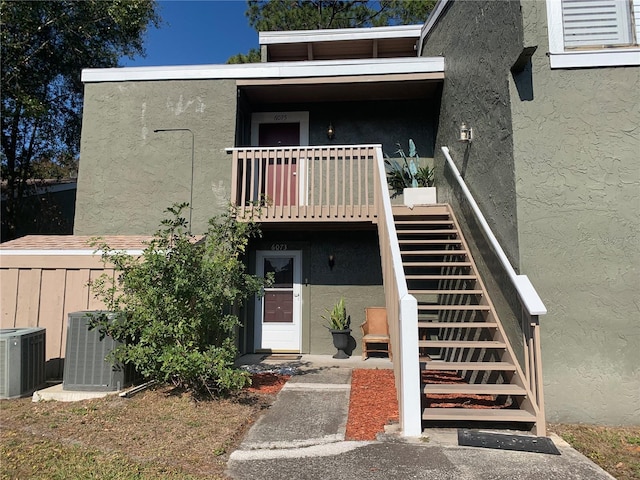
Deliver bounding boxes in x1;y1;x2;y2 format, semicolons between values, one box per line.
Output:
345;369;398;440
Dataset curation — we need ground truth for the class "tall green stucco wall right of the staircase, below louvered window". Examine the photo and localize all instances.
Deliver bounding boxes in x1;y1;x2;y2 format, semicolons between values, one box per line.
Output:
422;1;640;424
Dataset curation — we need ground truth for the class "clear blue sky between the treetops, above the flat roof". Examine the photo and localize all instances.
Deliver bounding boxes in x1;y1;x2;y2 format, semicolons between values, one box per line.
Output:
120;0;258;67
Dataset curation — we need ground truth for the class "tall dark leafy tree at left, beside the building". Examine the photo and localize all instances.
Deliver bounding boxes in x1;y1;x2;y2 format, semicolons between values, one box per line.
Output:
0;0;160;238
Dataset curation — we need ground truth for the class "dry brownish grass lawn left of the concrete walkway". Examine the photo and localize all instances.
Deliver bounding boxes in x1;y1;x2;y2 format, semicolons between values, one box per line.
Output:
0;387;274;480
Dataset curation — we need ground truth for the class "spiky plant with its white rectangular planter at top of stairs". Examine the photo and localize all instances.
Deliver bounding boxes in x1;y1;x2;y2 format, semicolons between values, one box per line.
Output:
384;139;437;207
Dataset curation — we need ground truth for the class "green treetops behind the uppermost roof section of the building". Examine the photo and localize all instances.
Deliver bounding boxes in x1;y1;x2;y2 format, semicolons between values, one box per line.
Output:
227;0;436;63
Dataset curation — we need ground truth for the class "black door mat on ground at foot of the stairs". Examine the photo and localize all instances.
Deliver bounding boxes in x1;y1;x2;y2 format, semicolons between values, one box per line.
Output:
458;428;560;455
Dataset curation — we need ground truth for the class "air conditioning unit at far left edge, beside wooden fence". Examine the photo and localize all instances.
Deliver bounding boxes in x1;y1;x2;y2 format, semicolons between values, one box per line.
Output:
0;328;46;398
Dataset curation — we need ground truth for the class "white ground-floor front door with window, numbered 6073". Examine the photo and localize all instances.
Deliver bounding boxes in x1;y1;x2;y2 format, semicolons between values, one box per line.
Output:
254;250;302;352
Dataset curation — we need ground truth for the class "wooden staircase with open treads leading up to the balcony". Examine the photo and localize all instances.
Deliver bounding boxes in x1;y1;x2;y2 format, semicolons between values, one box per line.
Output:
393;205;544;431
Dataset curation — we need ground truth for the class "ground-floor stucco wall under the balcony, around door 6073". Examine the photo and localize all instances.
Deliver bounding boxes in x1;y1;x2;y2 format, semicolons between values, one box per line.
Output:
243;229;385;355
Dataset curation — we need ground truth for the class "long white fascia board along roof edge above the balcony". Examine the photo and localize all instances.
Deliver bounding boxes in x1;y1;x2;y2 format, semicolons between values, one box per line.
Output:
82;57;444;83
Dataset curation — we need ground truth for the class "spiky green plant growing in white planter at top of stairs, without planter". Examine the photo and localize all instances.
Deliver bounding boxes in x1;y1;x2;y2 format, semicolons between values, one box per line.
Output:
384;139;434;198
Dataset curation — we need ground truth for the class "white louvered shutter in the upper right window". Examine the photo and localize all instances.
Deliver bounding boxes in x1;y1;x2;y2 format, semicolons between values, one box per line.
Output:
562;0;640;48
